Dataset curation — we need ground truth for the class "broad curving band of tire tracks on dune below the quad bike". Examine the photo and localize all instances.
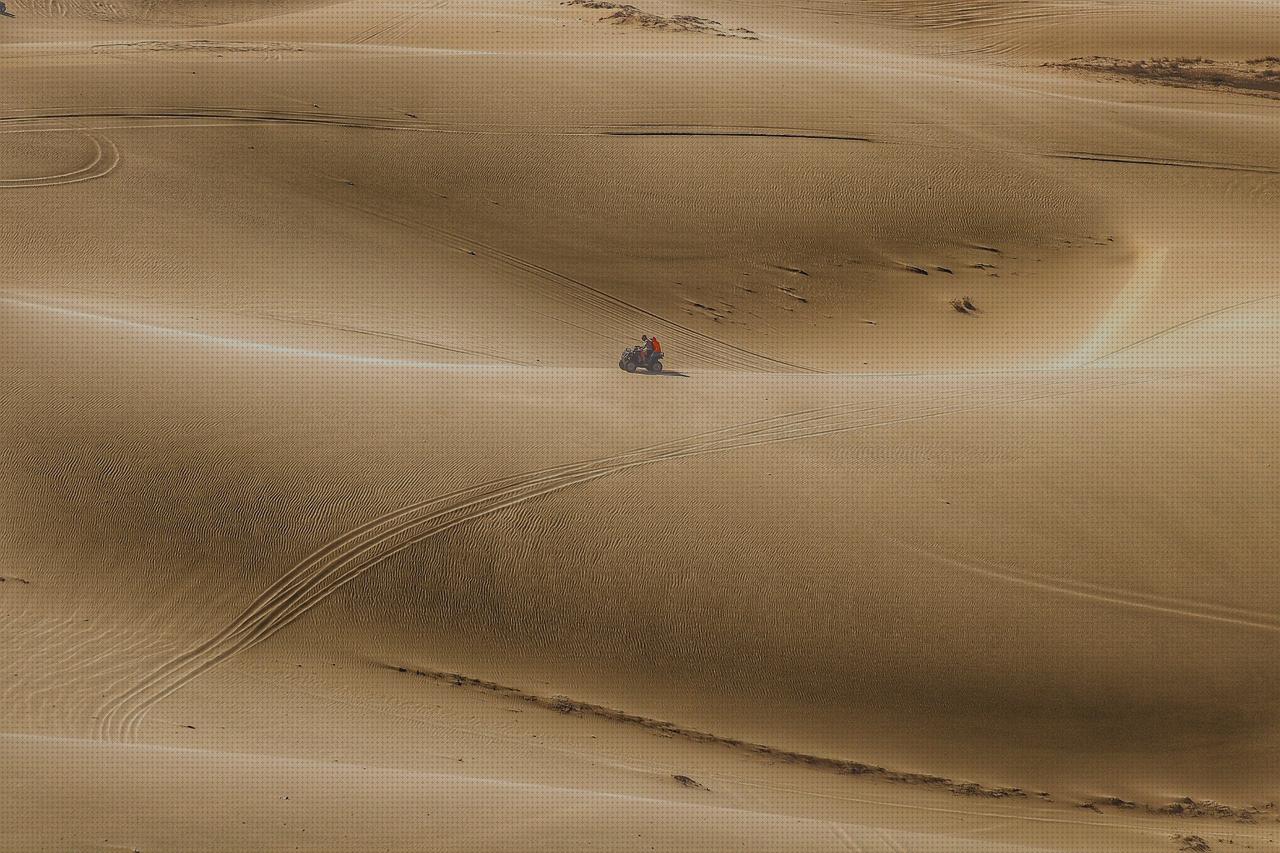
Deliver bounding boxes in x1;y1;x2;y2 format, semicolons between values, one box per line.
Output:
99;378;1152;740
